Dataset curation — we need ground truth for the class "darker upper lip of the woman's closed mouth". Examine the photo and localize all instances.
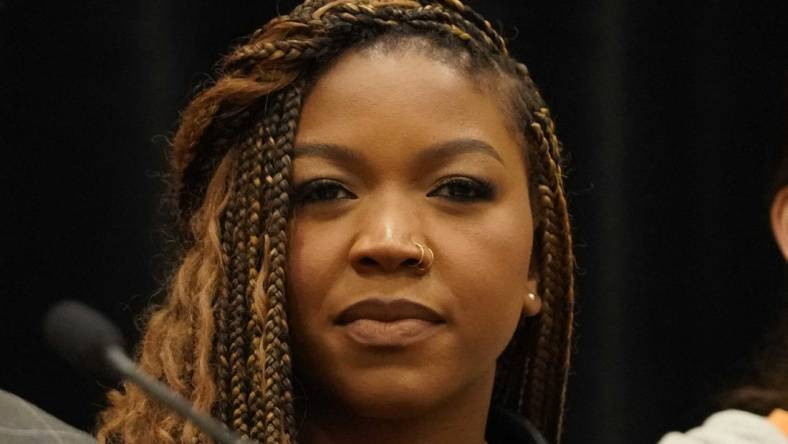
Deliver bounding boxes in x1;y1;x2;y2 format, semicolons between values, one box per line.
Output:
335;298;445;325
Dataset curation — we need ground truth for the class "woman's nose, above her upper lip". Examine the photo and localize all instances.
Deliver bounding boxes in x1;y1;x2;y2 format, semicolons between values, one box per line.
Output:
349;198;421;273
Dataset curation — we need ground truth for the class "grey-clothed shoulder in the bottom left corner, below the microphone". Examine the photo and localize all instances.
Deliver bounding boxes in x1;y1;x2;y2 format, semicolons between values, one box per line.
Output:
0;390;96;444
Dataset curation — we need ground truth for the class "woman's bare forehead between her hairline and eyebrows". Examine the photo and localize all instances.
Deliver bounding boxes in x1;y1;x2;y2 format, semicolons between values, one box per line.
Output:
296;50;522;165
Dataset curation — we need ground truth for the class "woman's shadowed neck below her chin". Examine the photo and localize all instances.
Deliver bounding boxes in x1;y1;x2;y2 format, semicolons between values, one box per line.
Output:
298;368;494;444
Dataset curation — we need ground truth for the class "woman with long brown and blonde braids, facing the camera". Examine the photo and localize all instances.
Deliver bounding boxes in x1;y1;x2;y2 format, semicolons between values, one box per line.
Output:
98;0;573;443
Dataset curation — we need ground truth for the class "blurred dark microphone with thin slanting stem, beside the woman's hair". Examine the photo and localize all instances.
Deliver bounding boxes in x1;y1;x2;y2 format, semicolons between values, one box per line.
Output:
44;301;252;444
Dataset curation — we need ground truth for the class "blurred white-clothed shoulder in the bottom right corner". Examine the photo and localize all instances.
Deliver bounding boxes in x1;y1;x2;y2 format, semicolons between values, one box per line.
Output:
658;410;788;444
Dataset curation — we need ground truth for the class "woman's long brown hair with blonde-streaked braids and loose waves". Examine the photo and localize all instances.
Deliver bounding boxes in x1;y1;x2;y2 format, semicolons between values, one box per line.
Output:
97;0;574;444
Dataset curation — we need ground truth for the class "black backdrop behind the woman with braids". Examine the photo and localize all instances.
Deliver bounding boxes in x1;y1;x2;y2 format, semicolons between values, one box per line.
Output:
0;0;788;443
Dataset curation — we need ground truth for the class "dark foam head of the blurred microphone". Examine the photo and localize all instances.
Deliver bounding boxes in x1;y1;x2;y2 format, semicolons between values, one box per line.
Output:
43;301;123;376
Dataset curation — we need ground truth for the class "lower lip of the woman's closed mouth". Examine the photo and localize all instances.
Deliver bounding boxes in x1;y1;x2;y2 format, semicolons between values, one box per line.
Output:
343;319;443;347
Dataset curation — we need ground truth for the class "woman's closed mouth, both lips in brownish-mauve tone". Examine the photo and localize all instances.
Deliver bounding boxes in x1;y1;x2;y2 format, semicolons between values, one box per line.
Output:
334;299;446;348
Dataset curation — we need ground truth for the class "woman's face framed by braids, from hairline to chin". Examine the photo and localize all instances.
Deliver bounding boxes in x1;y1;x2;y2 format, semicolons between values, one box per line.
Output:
288;46;533;417
